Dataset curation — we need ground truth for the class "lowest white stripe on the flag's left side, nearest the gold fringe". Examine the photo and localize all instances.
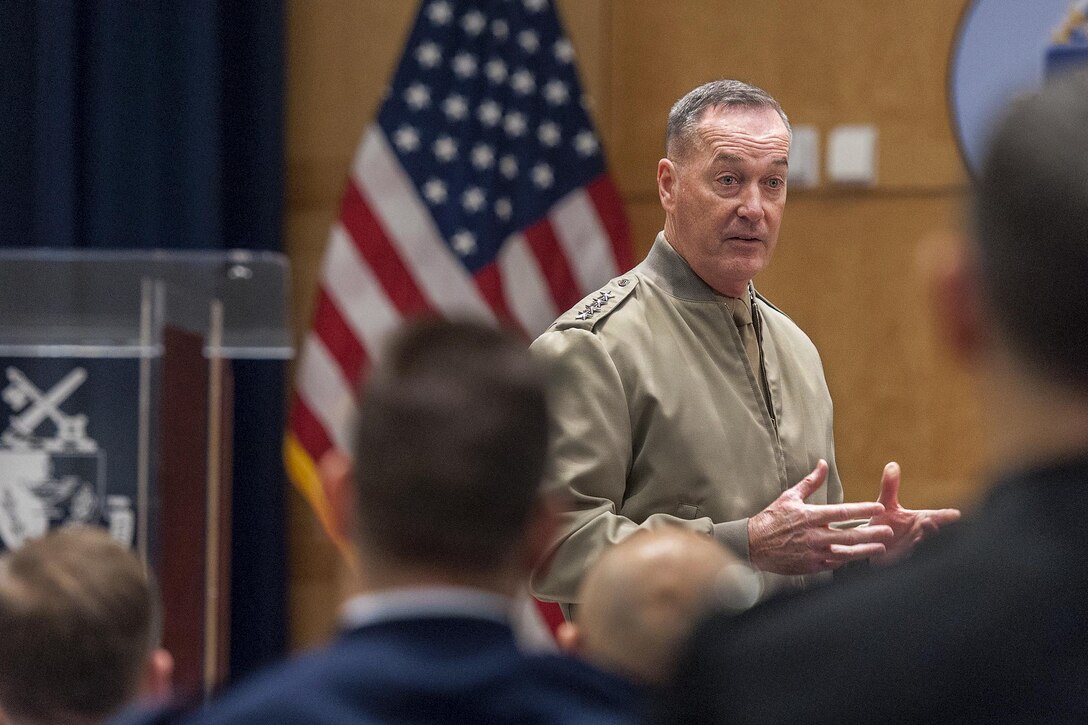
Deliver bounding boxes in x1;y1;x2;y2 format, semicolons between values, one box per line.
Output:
298;332;356;451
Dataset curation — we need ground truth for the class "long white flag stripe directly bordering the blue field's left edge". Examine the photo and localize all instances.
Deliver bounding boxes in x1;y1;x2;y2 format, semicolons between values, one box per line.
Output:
353;123;495;320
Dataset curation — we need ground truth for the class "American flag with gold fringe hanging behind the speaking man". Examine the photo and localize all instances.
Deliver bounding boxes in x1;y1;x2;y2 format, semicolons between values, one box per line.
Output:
285;0;632;557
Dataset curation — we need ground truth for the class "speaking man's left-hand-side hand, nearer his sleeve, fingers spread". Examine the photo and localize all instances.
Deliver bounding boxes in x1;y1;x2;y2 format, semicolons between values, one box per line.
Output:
749;459;895;574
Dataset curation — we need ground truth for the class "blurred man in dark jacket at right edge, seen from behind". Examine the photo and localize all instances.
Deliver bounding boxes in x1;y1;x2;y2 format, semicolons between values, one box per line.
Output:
662;69;1088;723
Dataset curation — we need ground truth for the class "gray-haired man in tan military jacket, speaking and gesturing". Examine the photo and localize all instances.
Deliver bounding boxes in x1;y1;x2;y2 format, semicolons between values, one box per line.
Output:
532;81;959;603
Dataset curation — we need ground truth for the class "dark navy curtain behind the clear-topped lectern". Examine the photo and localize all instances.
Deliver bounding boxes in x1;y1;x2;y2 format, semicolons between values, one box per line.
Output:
0;0;286;678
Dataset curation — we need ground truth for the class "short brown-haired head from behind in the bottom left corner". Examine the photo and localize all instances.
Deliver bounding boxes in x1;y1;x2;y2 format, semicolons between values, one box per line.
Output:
0;526;173;725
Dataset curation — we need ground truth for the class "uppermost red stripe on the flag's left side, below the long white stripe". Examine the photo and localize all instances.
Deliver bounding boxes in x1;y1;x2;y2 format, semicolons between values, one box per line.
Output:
341;180;431;317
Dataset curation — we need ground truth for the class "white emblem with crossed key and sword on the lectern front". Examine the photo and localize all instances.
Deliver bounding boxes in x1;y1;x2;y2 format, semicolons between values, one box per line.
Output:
0;367;134;549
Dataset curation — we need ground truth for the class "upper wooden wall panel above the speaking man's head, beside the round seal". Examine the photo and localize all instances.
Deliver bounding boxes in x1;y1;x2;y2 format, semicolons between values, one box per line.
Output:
603;0;964;200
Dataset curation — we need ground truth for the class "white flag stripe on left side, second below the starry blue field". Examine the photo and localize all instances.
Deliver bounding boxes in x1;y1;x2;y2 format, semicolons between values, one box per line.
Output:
322;222;400;356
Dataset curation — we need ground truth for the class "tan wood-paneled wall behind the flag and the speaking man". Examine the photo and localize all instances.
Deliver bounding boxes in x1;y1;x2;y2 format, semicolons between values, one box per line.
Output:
286;0;979;644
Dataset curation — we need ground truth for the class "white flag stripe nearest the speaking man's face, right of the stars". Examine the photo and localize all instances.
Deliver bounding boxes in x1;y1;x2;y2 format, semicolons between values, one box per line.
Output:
548;188;619;294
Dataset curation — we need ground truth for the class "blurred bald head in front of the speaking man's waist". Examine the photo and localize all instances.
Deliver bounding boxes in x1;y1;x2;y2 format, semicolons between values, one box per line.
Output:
559;528;735;684
